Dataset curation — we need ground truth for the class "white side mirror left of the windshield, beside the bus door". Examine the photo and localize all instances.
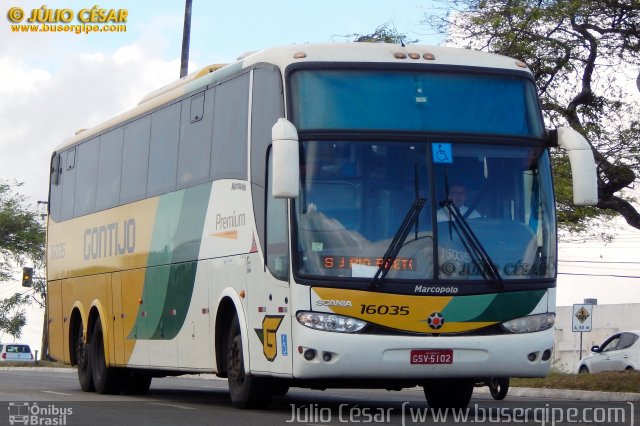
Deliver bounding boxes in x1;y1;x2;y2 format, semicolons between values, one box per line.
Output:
271;118;300;198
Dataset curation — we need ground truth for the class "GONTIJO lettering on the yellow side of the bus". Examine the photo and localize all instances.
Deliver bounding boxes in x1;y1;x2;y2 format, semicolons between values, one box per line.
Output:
84;219;136;260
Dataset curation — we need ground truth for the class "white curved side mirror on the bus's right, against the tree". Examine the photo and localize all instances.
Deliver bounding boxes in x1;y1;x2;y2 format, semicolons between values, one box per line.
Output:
556;127;598;206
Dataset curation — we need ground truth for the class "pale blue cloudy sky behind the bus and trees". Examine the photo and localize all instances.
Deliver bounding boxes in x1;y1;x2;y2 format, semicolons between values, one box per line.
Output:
0;0;640;348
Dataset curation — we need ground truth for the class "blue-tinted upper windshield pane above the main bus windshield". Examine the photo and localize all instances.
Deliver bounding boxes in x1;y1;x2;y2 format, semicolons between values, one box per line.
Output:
290;70;544;138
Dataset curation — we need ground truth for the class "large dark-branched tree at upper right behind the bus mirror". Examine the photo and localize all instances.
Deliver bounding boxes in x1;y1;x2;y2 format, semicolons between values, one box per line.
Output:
425;0;640;229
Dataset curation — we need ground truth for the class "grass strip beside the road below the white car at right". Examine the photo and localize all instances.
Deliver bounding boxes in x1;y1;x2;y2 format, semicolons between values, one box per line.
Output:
509;371;640;393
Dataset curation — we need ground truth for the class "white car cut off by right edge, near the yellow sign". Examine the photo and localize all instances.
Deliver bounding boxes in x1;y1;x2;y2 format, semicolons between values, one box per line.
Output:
578;331;640;373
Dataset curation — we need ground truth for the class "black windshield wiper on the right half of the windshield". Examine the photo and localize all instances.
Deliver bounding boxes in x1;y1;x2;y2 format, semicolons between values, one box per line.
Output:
440;199;503;287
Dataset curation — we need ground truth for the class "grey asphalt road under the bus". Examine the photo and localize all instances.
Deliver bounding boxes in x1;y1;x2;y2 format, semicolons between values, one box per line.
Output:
0;368;640;426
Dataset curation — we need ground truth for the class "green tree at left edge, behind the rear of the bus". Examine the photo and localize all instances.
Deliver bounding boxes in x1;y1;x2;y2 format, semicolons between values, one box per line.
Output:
0;181;45;338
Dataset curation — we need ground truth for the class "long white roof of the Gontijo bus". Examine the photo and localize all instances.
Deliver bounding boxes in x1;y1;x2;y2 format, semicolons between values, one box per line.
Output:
56;43;530;152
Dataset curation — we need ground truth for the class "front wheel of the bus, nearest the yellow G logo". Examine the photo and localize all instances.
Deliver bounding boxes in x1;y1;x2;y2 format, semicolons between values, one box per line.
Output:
227;317;271;408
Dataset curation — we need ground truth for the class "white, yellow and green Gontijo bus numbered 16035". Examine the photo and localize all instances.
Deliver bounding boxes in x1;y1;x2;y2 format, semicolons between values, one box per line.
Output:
47;43;597;408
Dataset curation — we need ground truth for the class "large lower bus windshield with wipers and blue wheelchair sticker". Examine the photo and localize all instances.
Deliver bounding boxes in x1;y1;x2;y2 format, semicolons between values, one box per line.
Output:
295;140;556;281
